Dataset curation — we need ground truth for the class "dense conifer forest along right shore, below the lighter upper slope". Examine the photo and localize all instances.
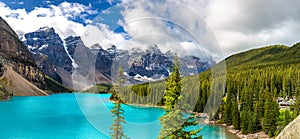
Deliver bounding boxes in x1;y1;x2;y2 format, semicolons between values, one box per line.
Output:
112;64;300;137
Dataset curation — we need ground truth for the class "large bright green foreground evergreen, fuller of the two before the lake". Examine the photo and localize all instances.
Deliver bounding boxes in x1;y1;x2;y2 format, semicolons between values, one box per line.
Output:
158;55;202;139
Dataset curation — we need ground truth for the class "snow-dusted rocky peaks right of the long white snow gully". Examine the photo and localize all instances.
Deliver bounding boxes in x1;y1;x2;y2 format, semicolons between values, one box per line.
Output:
65;36;215;82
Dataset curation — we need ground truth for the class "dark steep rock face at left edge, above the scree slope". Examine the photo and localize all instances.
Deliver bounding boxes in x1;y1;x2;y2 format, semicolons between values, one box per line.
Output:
0;17;45;89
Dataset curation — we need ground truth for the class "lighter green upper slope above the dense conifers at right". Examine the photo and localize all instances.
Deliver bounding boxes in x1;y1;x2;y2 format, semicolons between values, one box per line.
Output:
225;43;300;70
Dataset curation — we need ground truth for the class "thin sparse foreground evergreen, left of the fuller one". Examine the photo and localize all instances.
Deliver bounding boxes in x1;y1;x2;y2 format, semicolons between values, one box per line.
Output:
110;68;127;139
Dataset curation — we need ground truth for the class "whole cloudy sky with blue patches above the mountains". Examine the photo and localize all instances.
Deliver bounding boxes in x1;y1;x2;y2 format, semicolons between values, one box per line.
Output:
0;0;300;60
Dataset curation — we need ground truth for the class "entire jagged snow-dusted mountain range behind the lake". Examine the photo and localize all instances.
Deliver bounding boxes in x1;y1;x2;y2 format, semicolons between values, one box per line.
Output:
24;27;215;83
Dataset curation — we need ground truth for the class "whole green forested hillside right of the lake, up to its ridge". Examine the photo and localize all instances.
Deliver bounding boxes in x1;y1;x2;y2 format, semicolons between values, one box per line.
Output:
112;43;300;137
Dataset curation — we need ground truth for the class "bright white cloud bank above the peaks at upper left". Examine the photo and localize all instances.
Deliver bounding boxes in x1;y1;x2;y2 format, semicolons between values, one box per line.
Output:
0;2;96;38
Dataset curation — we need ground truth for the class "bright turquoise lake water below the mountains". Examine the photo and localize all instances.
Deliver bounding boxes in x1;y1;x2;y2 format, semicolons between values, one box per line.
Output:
0;94;231;139
